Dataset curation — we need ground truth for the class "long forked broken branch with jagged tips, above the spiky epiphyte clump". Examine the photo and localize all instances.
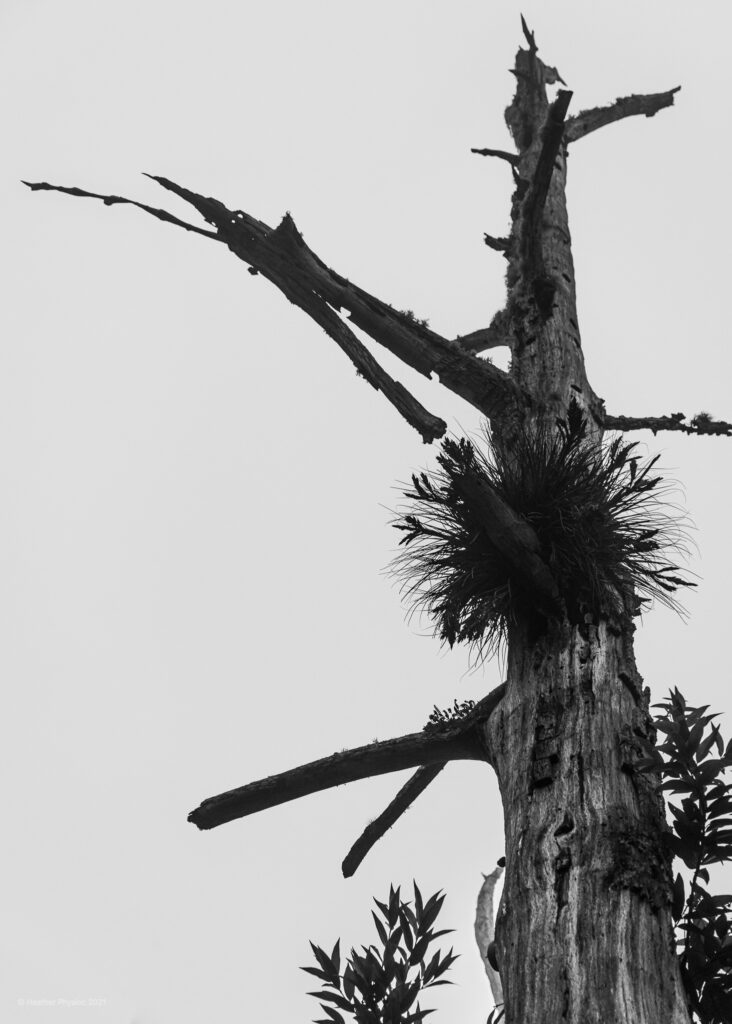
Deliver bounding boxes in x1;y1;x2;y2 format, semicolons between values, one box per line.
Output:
26;175;523;432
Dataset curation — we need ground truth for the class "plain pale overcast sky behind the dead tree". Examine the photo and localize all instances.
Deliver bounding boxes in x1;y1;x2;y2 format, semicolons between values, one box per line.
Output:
0;0;732;1024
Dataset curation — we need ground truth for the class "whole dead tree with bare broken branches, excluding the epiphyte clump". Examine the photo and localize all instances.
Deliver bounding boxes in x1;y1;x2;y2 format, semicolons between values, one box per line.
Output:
27;24;732;1024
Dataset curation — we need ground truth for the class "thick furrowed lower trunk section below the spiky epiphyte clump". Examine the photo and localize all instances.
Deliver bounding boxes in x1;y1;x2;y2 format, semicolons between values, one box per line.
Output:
485;624;689;1024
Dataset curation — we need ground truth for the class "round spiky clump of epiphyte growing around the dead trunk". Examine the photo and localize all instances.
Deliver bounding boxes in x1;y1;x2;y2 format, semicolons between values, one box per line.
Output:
393;401;695;656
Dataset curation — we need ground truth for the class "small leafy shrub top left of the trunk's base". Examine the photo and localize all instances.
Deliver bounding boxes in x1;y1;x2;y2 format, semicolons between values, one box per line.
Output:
301;883;458;1024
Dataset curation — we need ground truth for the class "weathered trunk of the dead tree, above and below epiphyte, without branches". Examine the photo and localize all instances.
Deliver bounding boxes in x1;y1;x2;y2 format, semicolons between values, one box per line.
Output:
485;32;690;1024
